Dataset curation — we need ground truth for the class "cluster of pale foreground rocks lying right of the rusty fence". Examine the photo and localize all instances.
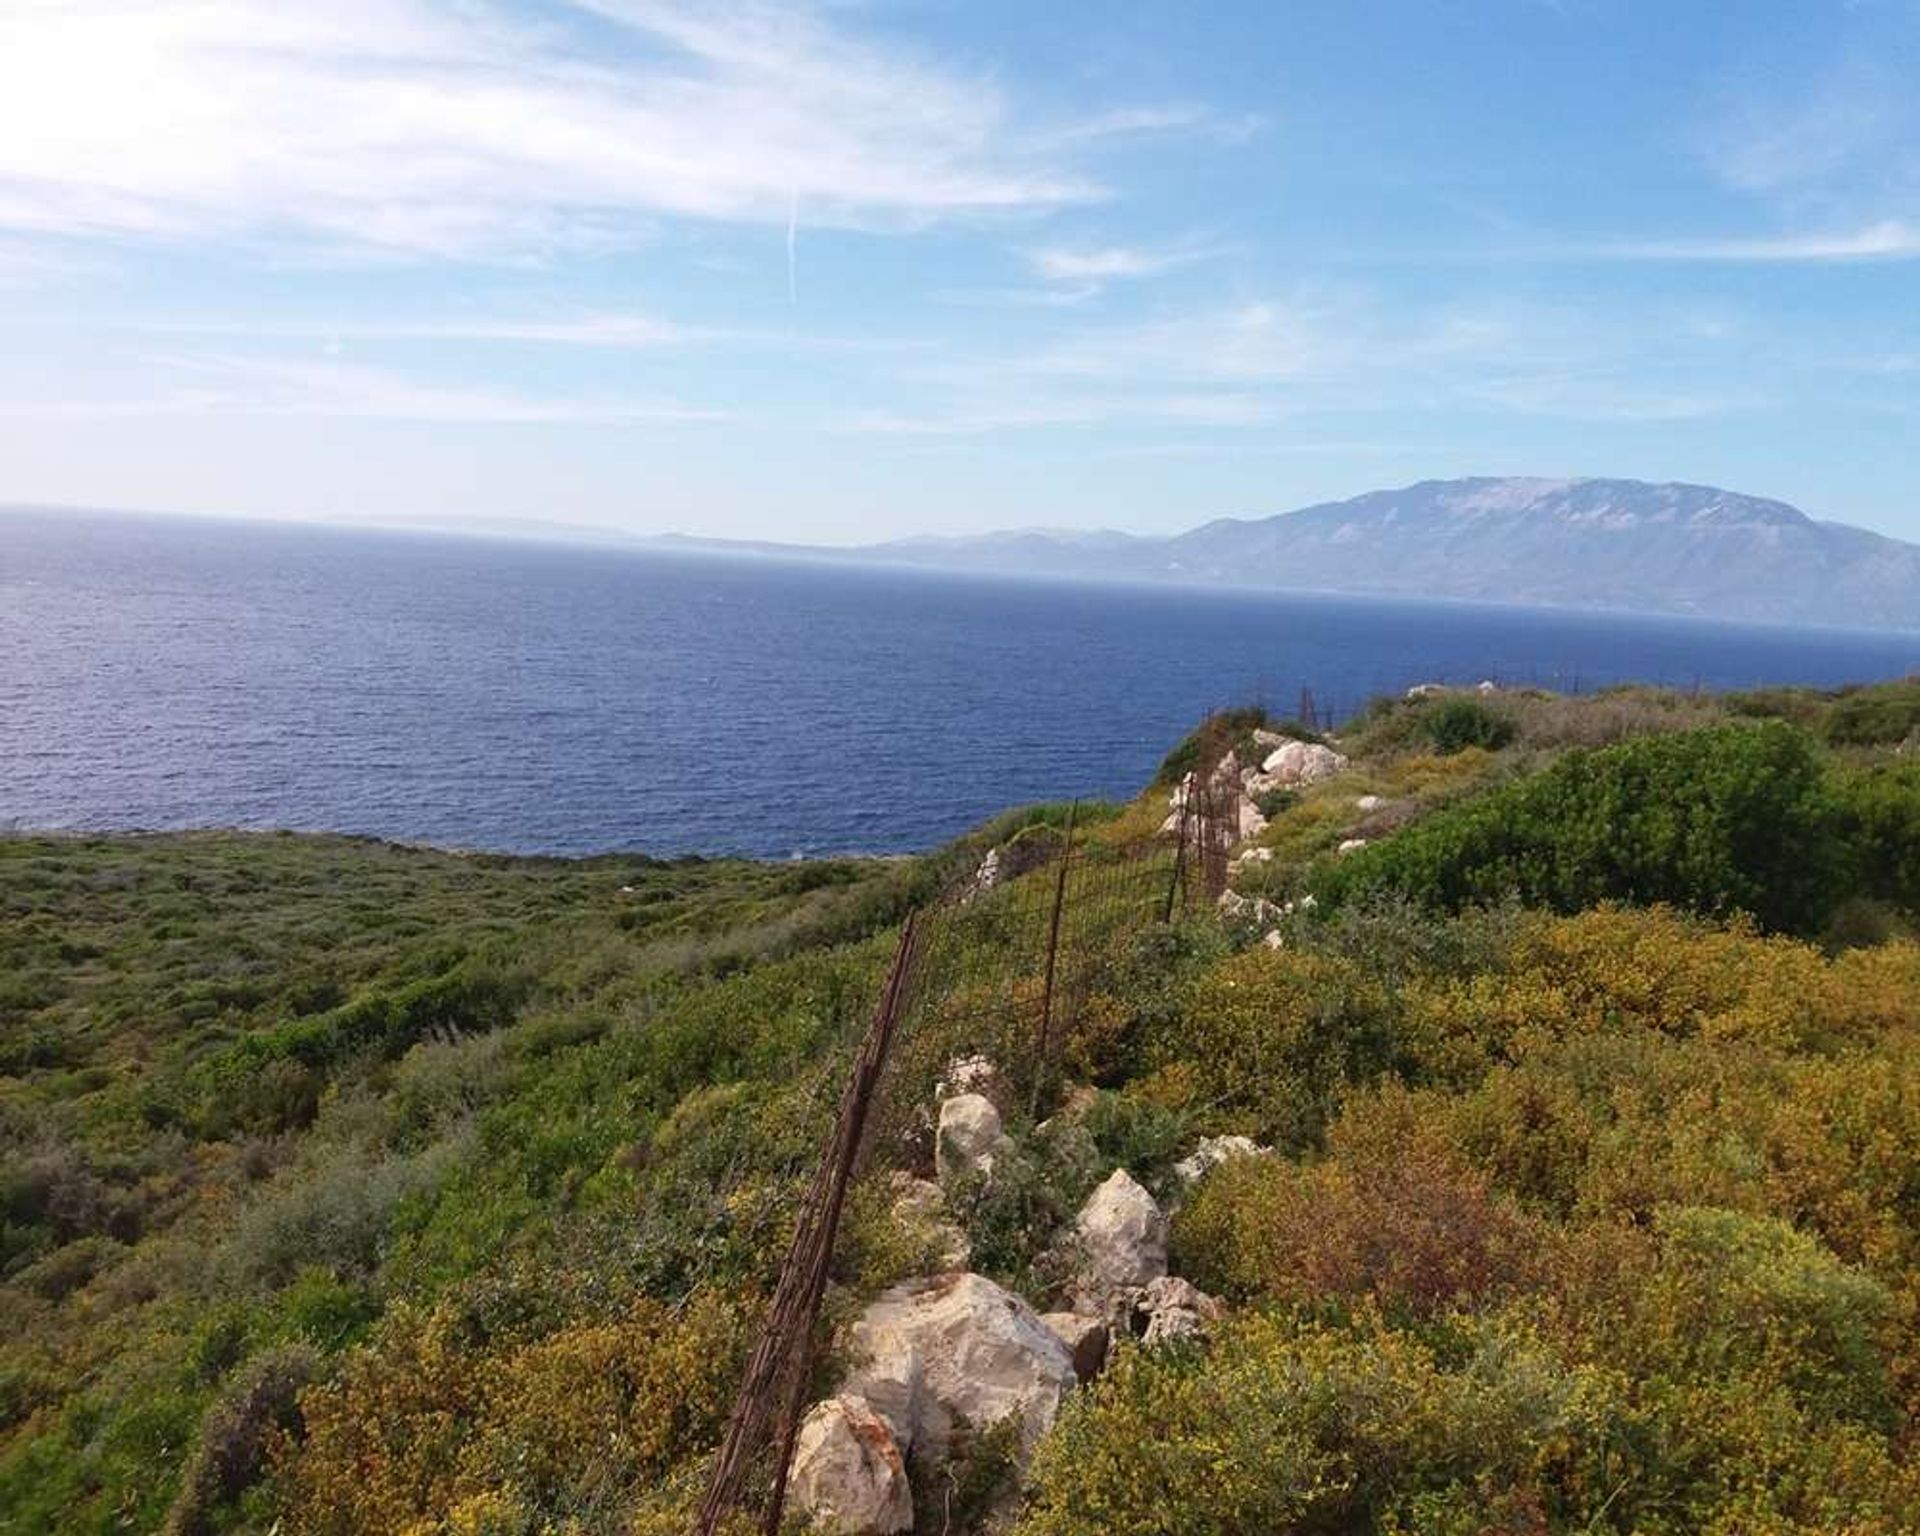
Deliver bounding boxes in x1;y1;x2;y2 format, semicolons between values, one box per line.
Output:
789;1058;1265;1536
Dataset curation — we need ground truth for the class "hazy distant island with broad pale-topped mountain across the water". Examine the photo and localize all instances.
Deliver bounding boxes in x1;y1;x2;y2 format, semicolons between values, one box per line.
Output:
662;476;1920;630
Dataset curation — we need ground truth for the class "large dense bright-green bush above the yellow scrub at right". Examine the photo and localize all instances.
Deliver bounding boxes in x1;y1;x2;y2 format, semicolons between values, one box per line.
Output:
1313;722;1849;933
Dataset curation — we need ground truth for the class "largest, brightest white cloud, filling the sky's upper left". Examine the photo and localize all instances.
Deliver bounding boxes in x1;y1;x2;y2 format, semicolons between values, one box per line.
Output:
0;0;1192;255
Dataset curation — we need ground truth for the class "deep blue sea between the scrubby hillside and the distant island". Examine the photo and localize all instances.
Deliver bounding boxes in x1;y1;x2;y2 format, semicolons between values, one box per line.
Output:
0;513;1920;856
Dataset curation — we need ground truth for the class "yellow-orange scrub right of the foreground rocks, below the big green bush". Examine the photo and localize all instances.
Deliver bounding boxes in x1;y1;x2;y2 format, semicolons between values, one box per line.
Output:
1023;908;1920;1532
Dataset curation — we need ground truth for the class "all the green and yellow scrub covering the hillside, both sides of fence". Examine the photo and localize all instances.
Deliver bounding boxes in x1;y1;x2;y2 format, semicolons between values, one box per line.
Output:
0;682;1920;1536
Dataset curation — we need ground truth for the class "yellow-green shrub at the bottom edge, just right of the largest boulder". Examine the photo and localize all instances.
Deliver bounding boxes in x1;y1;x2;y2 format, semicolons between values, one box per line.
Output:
1016;1317;1613;1536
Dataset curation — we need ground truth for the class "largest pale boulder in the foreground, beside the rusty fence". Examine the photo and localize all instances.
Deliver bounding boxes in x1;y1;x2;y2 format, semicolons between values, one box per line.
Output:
841;1275;1075;1461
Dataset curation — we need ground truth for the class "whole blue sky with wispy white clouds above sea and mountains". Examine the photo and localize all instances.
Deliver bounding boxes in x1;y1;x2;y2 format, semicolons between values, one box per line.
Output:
0;0;1920;541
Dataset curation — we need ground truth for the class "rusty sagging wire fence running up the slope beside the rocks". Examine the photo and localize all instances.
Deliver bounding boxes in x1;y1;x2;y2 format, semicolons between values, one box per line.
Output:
697;722;1238;1536
